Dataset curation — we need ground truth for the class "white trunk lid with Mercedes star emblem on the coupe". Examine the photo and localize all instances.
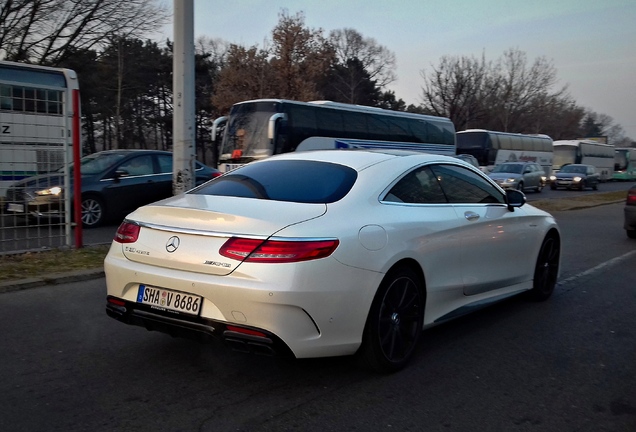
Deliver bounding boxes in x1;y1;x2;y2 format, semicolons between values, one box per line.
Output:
122;194;326;276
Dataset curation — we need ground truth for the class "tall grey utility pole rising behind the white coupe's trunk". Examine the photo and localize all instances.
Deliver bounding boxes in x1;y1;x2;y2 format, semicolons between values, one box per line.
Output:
172;0;196;195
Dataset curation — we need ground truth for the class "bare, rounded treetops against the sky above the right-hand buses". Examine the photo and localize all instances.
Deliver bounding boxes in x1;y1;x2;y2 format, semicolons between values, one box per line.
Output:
421;49;583;135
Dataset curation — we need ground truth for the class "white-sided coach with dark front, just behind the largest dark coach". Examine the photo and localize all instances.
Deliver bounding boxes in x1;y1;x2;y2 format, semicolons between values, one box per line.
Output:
457;129;552;176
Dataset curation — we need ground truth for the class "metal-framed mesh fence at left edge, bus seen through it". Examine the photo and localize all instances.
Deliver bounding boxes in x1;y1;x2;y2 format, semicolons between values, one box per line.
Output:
0;62;79;253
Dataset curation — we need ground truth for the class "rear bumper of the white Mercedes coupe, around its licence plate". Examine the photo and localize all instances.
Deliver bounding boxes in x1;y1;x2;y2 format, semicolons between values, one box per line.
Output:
104;243;383;358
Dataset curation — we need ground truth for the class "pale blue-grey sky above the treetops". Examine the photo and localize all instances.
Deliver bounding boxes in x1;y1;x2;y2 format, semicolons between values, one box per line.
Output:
159;0;636;140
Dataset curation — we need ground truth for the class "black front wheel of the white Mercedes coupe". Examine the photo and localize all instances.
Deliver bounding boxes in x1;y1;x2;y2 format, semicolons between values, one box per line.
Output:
529;234;561;301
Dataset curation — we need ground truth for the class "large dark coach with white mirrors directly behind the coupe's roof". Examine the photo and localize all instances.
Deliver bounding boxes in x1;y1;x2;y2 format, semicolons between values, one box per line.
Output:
212;99;455;172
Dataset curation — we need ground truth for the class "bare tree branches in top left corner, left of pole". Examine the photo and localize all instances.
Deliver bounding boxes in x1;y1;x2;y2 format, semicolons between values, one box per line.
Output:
0;0;169;65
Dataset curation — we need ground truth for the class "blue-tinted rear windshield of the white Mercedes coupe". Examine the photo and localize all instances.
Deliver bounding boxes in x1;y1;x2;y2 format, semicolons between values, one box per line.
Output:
189;160;357;204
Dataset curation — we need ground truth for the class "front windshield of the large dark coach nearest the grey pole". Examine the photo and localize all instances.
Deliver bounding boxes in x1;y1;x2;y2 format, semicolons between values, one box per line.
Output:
221;102;278;160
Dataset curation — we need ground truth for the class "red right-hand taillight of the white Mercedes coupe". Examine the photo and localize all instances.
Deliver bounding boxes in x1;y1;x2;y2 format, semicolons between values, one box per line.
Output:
219;237;340;263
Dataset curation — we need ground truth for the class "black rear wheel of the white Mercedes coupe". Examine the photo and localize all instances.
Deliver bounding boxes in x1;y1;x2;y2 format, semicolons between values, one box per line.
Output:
357;267;425;373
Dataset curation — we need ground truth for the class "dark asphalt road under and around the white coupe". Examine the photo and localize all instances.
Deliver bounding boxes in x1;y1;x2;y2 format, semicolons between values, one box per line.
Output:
0;204;636;432
